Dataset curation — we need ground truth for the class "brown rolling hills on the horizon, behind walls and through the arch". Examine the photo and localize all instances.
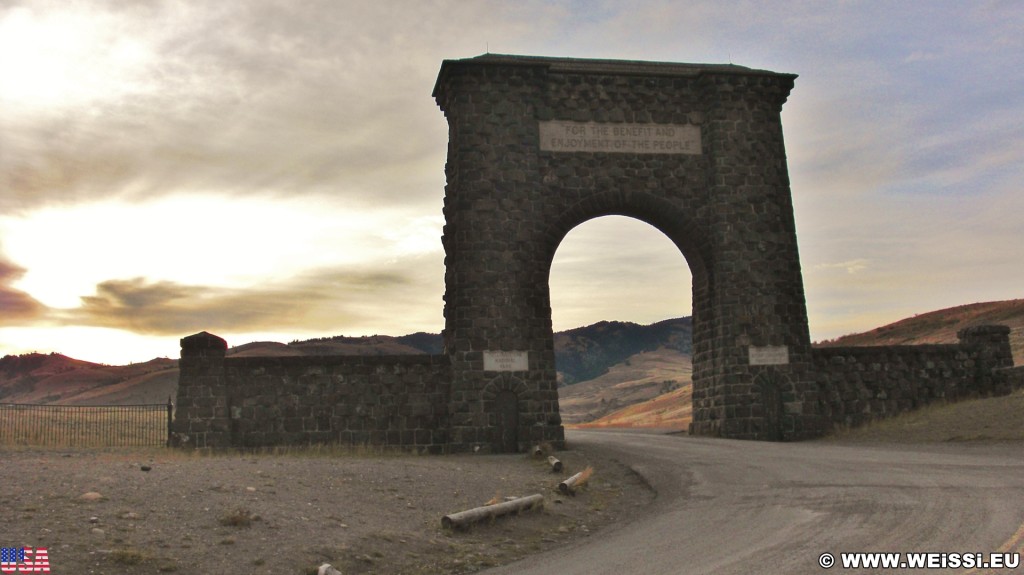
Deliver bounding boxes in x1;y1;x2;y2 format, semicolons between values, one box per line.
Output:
6;300;1024;429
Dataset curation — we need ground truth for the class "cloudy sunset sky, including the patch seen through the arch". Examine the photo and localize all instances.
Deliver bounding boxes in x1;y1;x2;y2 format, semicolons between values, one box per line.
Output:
0;0;1024;364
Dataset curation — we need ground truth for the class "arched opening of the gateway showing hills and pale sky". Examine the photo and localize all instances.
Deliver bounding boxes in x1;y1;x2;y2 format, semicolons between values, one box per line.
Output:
549;215;693;430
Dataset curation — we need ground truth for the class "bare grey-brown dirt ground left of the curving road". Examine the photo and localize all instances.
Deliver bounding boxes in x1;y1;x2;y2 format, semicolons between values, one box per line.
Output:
0;448;653;575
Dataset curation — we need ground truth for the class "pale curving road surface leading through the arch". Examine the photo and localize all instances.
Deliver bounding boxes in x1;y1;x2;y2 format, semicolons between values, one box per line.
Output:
485;431;1024;575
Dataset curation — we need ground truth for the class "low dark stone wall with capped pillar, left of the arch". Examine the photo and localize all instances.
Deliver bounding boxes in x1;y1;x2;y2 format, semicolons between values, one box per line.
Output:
174;333;451;453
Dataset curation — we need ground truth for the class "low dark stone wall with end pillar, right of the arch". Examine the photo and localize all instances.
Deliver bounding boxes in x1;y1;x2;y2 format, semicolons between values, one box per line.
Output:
812;325;1016;427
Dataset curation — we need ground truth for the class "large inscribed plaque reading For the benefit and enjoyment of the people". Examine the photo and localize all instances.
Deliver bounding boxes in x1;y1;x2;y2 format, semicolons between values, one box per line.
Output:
539;120;700;154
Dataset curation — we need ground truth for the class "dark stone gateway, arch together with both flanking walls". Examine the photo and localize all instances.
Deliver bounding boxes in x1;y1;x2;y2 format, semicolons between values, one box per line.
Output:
174;54;1024;453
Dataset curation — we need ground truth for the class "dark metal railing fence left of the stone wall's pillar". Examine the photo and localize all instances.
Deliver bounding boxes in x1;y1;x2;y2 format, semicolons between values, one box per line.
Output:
0;399;174;447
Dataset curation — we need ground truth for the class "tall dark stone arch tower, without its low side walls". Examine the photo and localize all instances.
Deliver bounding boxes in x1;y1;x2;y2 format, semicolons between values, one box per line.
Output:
434;54;821;450
